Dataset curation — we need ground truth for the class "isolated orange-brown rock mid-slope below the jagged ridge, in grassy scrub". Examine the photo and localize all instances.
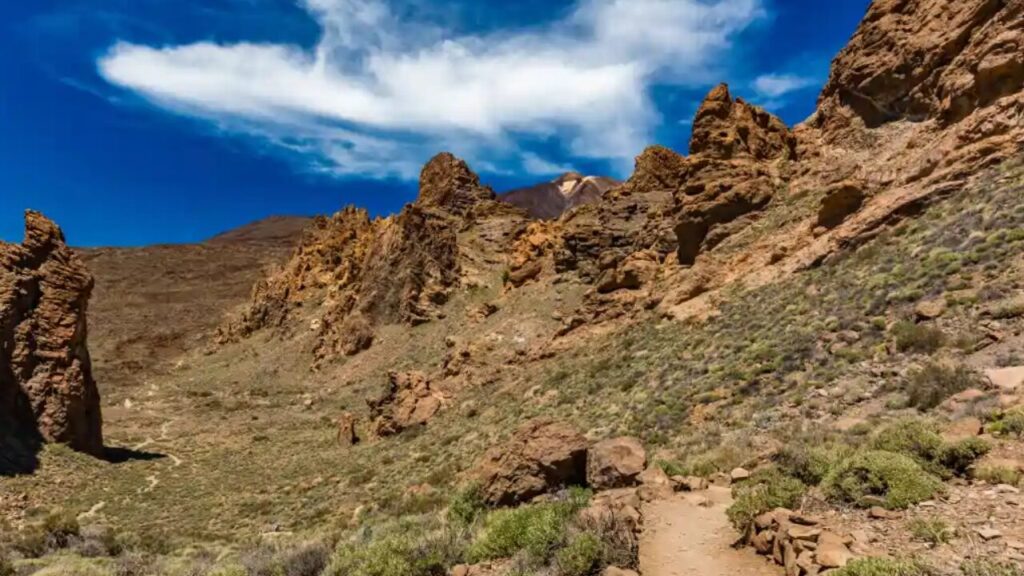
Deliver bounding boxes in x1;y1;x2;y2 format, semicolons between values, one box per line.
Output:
367;372;446;438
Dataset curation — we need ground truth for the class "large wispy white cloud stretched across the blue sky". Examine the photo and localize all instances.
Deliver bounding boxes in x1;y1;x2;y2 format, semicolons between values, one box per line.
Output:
98;0;765;177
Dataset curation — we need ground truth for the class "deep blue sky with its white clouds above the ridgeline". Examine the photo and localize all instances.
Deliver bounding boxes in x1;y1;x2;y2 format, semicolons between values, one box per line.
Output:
0;0;868;246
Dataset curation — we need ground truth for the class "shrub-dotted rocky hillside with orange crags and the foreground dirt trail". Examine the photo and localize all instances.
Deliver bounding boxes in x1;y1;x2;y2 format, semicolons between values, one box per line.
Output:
0;0;1024;576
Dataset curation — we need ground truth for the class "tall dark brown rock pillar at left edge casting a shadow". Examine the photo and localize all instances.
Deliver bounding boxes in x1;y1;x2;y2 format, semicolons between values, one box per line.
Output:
0;211;103;456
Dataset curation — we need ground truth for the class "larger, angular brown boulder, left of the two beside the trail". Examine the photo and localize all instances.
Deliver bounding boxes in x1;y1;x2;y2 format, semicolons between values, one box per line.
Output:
472;420;587;506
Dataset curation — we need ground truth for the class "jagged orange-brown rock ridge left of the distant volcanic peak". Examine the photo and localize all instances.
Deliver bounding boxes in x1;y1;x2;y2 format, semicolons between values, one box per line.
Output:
218;154;525;360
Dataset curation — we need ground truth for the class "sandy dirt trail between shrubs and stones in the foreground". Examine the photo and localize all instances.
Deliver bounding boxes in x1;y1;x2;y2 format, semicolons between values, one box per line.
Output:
640;487;782;576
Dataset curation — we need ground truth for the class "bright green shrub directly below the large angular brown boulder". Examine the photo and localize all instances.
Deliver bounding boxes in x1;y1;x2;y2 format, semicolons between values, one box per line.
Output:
468;502;579;566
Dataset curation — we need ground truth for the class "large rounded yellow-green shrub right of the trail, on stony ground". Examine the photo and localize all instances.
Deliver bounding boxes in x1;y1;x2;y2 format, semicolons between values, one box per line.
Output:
822;450;943;509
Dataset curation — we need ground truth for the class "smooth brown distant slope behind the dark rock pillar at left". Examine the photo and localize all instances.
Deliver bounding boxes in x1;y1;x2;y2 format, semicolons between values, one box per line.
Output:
76;217;310;396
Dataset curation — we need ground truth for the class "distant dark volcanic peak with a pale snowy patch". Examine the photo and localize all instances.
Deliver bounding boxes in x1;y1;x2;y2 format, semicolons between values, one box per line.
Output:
498;172;621;220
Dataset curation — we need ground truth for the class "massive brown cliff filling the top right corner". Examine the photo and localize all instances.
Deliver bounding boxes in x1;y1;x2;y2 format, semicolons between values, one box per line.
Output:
821;0;1024;128
